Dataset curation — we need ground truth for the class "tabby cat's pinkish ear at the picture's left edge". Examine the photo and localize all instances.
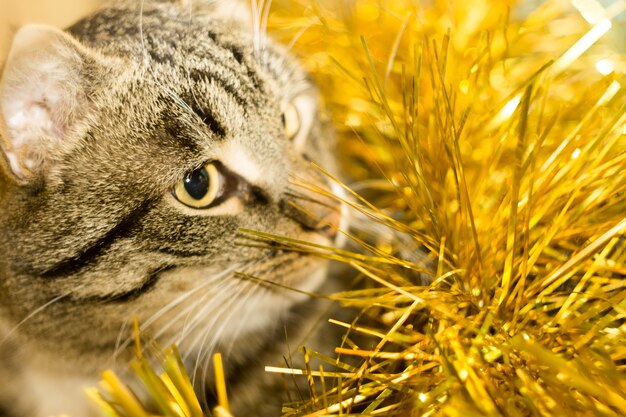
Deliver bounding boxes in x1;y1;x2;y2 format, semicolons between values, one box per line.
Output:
0;25;93;179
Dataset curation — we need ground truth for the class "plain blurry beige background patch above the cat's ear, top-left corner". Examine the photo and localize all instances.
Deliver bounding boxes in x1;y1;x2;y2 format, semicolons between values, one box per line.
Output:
0;0;99;62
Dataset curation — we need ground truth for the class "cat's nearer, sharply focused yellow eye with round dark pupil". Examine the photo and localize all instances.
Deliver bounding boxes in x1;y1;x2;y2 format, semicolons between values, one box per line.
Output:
173;162;224;209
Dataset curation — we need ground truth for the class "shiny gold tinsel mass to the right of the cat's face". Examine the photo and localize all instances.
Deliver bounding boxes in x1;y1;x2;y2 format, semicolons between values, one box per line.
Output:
94;0;626;416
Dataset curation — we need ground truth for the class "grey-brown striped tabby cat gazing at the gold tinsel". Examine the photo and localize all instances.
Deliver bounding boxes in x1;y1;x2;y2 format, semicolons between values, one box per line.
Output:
0;0;339;417
